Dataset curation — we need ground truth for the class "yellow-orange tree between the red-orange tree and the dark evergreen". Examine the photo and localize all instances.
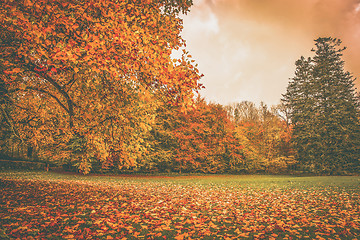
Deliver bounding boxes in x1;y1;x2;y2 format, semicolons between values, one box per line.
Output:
226;101;295;173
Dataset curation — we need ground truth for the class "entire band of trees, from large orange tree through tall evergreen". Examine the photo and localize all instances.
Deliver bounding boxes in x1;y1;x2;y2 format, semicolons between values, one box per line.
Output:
0;0;360;174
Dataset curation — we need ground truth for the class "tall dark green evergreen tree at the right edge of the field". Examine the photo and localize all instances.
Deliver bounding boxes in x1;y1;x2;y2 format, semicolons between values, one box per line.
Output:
282;37;360;174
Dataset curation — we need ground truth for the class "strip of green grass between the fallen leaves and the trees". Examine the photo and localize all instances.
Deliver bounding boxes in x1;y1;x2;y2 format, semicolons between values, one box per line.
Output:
0;171;360;191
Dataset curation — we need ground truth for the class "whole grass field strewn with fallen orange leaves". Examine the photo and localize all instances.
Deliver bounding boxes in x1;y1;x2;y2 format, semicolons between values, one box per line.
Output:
0;172;360;239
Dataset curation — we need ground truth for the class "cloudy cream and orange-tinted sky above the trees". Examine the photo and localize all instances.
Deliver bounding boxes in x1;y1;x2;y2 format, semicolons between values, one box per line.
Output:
182;0;360;105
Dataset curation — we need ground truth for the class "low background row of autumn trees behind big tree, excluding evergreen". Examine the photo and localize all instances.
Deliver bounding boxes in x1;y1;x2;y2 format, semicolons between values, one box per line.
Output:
1;94;296;173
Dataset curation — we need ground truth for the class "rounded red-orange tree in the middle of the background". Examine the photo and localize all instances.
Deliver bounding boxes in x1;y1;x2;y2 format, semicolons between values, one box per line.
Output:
174;97;244;173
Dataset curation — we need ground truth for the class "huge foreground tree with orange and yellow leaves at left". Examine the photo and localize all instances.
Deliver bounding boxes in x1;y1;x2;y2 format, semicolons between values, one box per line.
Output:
0;0;200;173
